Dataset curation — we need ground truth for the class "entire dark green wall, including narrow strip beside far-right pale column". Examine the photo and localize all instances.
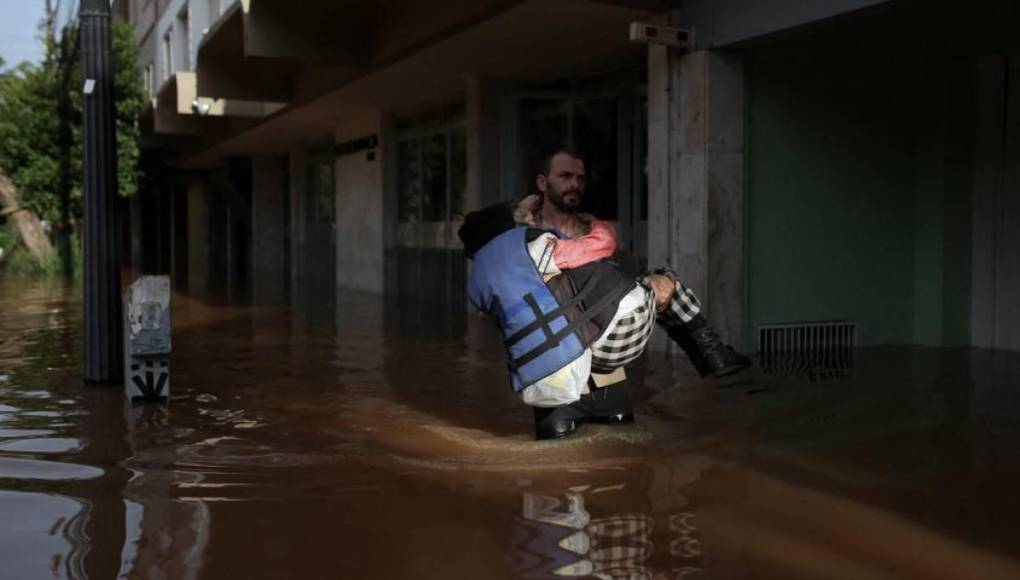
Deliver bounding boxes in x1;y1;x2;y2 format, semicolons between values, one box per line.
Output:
746;41;973;347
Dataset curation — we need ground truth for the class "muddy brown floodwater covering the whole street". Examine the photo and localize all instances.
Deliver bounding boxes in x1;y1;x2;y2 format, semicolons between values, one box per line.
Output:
0;276;1020;580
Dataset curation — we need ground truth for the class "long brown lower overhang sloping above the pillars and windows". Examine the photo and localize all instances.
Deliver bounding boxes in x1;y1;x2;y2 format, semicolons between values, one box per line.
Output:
183;0;661;163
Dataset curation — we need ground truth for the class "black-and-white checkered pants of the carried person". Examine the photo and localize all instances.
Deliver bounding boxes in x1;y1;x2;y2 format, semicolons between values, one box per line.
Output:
592;276;701;372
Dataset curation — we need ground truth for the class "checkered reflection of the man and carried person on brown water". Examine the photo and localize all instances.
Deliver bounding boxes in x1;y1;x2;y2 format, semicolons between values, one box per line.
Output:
512;456;711;578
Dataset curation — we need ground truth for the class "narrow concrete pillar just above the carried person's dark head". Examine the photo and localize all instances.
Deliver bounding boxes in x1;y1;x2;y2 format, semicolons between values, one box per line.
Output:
464;75;502;211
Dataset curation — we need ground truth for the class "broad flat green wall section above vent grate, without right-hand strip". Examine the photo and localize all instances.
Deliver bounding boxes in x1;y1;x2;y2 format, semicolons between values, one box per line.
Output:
747;49;916;346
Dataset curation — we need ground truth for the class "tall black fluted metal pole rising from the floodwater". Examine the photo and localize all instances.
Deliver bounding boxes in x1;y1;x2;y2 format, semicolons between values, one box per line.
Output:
79;0;123;384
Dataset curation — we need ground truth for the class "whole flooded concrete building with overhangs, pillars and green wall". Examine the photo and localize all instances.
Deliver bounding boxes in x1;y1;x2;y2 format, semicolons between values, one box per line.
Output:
114;0;1020;351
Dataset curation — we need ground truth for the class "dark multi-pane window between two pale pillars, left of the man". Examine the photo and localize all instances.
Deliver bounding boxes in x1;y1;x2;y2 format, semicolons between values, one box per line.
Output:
397;122;467;223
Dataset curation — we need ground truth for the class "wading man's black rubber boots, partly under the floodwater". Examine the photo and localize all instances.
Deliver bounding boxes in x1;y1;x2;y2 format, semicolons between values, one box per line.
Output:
533;380;634;440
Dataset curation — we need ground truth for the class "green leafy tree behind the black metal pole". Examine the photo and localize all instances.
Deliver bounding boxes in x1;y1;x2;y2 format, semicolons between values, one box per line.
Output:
0;14;145;273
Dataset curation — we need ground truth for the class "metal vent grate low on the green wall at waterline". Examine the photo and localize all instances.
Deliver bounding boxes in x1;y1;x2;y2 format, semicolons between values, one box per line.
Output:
758;320;858;380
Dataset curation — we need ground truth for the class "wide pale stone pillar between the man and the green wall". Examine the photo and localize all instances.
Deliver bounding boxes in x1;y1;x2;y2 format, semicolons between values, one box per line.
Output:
648;46;745;346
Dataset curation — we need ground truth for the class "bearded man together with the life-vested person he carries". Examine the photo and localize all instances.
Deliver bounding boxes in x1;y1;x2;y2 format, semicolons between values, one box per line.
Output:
458;150;750;439
